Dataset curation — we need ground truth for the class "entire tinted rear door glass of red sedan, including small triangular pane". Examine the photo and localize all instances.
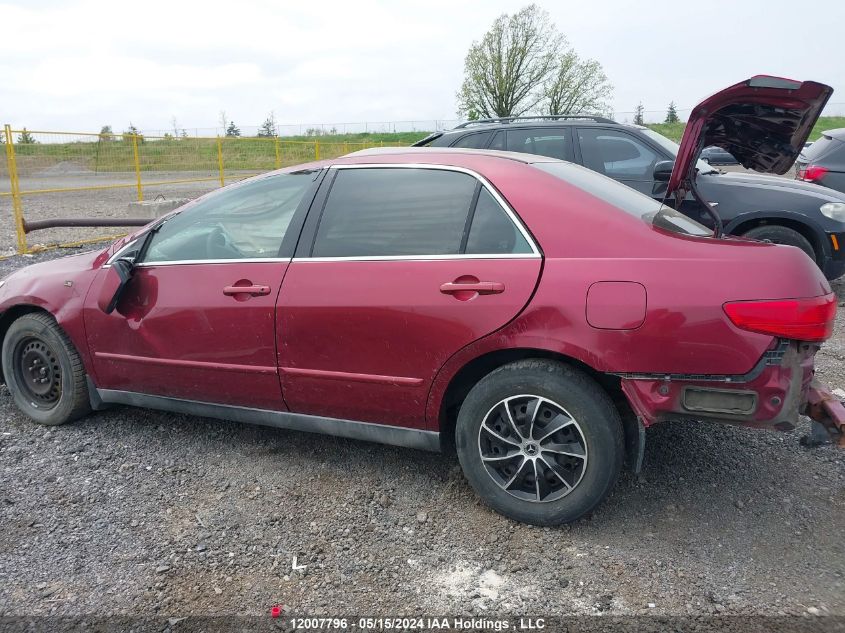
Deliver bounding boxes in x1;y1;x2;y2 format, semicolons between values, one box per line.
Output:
311;167;533;258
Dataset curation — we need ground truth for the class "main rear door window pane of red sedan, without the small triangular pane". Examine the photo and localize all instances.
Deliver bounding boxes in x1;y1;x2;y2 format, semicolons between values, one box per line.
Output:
312;167;477;257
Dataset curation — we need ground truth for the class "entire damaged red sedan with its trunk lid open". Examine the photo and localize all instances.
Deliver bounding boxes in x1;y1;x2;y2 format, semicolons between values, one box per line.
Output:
0;78;836;525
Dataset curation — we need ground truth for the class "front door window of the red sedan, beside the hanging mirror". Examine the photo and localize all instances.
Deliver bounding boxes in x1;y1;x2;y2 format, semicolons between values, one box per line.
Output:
144;171;315;262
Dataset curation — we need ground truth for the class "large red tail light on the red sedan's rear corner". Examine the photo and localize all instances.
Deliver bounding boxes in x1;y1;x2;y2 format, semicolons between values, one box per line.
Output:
722;294;836;341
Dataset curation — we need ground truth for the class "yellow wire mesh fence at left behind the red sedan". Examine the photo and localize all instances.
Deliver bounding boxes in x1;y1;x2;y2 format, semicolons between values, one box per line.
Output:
0;125;396;254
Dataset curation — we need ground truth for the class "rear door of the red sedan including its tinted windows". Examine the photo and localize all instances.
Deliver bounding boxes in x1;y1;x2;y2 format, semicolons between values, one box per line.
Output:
277;165;541;428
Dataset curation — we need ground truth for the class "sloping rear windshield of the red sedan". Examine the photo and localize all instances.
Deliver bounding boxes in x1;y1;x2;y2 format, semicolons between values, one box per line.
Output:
532;161;713;236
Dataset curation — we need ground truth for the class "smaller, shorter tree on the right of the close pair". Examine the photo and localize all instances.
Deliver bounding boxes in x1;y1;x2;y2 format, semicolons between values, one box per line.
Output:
543;49;613;114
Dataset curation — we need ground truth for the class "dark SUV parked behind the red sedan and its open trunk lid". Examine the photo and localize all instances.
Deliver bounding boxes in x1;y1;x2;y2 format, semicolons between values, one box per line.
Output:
416;116;845;279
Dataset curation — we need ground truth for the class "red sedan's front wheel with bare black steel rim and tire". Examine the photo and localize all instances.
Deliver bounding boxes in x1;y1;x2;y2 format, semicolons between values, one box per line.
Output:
2;312;91;426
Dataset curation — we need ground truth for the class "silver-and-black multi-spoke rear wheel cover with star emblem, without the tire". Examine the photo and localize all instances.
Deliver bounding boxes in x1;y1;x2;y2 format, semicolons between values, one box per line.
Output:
478;395;587;503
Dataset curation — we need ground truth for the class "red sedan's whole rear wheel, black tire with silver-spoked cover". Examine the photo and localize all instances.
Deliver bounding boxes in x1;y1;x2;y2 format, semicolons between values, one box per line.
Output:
455;360;624;526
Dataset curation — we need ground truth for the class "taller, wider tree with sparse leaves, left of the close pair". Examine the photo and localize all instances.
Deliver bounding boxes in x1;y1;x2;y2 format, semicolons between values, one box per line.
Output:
457;4;564;117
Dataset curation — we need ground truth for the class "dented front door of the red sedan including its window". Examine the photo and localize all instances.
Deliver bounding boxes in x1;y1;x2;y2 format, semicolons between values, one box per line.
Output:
84;172;319;410
